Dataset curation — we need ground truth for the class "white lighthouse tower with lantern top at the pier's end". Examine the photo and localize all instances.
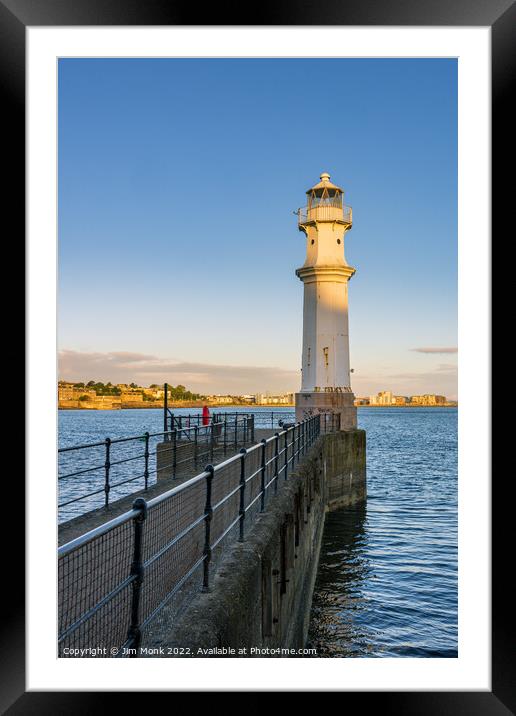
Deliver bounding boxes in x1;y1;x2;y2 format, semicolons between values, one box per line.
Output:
296;173;357;430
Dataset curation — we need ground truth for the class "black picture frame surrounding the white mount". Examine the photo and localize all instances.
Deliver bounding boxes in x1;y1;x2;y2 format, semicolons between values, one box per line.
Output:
7;0;508;716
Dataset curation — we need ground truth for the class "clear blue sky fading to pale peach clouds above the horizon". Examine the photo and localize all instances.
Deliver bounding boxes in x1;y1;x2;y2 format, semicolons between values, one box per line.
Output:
58;59;457;397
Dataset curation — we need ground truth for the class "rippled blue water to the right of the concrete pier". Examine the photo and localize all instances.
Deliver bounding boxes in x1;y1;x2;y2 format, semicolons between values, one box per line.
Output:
308;408;457;658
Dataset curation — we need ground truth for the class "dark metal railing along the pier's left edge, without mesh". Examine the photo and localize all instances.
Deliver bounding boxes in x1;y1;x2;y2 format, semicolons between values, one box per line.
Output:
58;414;254;521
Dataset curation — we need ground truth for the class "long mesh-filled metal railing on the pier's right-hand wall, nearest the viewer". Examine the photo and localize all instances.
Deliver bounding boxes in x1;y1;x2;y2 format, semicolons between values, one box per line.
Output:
58;416;322;657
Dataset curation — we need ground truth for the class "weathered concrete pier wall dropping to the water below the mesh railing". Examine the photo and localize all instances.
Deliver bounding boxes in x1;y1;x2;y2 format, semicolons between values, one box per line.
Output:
161;430;366;657
